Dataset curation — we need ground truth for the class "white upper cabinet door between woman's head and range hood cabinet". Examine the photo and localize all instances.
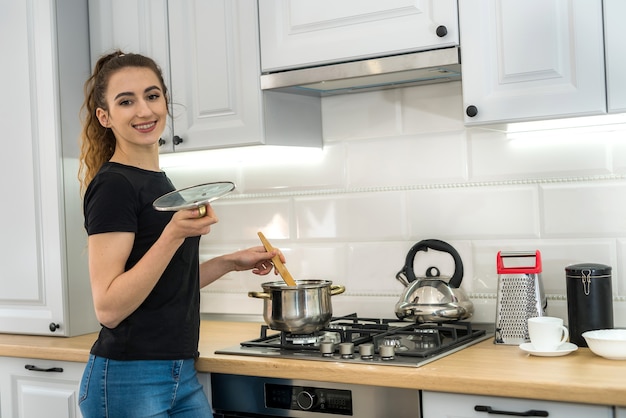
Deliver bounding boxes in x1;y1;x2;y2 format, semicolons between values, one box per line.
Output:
168;0;263;151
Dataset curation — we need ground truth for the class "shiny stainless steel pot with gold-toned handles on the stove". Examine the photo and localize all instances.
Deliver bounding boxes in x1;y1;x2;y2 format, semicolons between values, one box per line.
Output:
248;280;346;334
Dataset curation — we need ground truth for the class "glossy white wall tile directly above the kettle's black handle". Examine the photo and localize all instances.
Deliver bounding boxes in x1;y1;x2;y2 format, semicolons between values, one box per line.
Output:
407;185;540;239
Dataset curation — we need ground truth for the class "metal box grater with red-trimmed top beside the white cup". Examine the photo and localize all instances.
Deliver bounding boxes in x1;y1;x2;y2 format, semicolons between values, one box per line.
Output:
494;250;548;345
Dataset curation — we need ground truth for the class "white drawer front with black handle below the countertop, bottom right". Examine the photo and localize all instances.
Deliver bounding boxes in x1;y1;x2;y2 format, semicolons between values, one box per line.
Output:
422;392;613;418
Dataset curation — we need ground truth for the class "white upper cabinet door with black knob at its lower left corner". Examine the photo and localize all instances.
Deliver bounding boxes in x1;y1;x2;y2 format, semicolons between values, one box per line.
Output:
459;0;606;125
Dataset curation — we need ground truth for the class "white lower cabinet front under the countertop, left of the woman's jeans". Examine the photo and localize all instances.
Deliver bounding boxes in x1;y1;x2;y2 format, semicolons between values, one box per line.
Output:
0;357;85;418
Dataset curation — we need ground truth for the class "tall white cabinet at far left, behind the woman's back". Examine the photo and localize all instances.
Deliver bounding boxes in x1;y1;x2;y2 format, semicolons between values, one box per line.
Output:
0;0;99;334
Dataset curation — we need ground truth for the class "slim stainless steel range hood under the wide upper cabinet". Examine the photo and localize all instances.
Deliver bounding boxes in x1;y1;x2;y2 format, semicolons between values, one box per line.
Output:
261;47;461;96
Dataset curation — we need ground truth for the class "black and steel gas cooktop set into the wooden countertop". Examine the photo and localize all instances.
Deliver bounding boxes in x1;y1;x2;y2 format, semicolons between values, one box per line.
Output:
215;314;493;367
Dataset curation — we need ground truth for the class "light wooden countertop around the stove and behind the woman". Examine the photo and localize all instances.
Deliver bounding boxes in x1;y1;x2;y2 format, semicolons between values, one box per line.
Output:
0;321;626;406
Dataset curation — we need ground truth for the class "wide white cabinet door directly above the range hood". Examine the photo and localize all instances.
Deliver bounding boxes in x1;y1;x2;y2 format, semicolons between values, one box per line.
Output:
259;0;459;72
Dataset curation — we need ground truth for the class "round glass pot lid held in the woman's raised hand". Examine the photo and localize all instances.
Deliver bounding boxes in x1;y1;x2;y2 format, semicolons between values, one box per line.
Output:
152;181;235;211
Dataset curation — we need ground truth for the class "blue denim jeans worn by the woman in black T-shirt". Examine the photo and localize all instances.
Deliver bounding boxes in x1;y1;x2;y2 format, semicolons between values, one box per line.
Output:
78;355;213;418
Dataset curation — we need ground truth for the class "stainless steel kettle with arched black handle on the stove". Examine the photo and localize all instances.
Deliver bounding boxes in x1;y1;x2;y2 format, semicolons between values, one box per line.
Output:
396;239;474;322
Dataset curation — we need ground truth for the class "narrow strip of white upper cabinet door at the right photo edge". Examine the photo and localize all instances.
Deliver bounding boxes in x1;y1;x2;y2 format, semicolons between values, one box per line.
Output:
603;0;626;113
